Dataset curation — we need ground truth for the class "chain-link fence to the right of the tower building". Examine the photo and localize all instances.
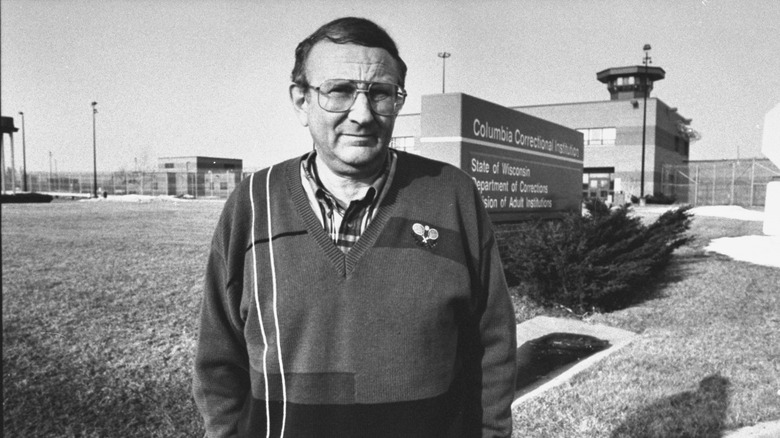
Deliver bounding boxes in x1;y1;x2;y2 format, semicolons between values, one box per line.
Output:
661;159;780;207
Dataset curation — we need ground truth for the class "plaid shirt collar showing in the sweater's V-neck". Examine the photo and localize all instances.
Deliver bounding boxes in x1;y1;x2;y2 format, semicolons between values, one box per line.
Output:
301;150;396;254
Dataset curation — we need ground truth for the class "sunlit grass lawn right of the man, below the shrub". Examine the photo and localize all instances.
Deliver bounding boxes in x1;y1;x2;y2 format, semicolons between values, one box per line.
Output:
514;210;780;438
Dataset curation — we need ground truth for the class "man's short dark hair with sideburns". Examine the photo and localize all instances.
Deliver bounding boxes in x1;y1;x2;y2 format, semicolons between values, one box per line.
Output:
292;17;406;87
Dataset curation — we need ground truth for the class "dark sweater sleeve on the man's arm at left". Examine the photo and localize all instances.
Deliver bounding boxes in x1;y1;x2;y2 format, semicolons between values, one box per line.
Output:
193;221;250;437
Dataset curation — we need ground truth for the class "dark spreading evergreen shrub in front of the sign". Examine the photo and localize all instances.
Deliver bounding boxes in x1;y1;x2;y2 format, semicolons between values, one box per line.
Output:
501;200;691;314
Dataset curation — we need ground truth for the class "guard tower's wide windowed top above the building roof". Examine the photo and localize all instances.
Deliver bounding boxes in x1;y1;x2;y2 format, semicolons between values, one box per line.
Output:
596;65;666;100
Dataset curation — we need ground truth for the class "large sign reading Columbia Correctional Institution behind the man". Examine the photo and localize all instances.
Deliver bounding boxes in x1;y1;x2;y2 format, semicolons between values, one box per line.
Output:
420;93;583;222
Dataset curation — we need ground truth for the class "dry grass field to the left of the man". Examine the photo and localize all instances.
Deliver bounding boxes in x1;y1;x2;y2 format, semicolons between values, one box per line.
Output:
2;202;222;437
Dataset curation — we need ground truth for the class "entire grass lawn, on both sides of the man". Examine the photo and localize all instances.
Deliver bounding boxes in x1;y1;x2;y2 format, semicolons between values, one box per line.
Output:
2;201;780;438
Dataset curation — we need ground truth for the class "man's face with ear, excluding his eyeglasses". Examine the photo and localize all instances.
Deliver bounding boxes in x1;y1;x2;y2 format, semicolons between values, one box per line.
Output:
290;41;400;178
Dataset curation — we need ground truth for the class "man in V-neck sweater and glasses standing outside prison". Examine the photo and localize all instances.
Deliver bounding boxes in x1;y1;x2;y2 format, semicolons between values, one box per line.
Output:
193;18;515;438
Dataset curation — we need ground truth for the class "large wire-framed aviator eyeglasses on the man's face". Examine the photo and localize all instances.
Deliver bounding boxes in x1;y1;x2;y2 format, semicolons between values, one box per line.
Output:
310;79;406;116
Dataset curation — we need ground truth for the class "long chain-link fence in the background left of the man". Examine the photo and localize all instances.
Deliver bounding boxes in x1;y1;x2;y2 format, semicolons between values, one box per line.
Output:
4;170;248;199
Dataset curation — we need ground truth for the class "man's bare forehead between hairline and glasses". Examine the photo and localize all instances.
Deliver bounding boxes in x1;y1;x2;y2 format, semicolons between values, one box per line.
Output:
306;41;400;80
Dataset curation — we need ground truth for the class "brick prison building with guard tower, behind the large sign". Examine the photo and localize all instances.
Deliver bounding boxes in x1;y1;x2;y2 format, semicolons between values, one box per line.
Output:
393;66;698;200
